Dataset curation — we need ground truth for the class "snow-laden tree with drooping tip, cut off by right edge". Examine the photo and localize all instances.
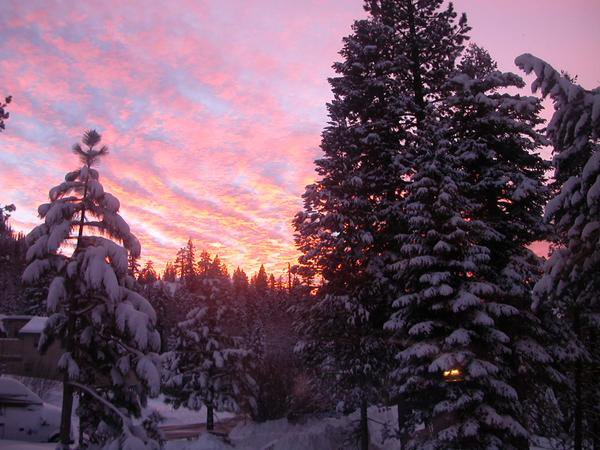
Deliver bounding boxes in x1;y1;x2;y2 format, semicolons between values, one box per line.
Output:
515;54;600;450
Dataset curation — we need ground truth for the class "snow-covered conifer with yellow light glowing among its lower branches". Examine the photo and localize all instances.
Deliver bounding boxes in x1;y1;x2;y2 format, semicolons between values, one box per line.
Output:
386;112;527;449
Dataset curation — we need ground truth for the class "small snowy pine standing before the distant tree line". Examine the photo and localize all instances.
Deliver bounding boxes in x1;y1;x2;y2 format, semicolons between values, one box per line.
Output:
164;253;254;430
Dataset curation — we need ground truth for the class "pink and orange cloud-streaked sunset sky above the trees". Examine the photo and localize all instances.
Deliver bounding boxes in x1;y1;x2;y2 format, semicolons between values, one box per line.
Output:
0;0;600;275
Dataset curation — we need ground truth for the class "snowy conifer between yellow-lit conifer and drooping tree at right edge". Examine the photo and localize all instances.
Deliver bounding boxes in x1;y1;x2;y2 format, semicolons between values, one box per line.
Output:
444;45;561;440
